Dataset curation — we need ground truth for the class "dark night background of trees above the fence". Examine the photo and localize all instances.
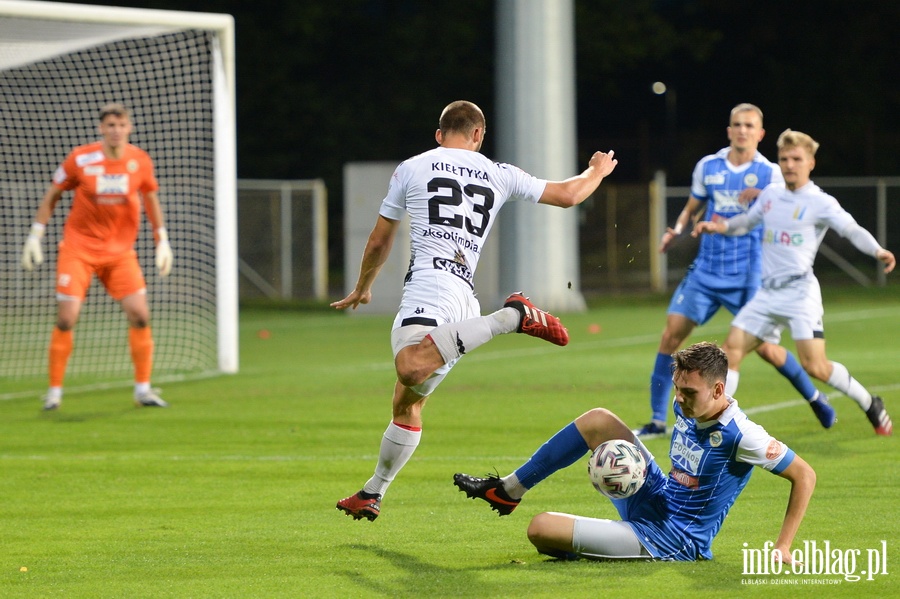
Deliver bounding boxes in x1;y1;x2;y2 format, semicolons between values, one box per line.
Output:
54;0;900;272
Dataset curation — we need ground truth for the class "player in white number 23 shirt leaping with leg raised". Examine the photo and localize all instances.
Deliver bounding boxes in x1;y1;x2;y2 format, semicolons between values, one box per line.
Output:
331;101;618;521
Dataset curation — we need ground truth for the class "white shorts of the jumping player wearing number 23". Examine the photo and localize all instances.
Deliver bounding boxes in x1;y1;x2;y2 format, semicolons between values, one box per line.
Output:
391;270;481;397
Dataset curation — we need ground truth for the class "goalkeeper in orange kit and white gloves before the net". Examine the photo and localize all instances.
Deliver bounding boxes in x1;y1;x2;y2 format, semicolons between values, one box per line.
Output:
22;104;172;410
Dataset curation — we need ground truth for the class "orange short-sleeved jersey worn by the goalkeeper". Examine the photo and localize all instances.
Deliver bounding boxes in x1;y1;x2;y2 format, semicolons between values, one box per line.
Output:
53;141;159;257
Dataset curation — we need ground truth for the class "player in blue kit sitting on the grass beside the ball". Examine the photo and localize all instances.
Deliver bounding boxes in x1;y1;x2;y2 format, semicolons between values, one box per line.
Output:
454;342;816;563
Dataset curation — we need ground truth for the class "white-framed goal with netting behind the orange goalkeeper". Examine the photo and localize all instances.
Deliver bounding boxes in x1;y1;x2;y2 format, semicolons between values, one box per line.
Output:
0;0;238;387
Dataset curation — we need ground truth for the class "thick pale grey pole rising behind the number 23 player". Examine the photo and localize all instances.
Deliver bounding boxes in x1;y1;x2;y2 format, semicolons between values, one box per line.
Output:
489;0;585;311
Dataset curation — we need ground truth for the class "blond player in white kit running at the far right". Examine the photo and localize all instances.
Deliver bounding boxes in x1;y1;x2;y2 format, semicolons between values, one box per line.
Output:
693;129;896;435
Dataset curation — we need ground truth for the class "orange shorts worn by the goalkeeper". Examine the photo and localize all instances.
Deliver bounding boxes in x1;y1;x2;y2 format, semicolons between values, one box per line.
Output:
56;243;147;302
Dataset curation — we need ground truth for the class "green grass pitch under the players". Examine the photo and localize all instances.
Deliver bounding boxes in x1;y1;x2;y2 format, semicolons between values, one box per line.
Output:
0;285;900;599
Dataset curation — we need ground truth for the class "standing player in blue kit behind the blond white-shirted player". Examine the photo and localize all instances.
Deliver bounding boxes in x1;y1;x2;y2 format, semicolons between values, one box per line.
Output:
634;104;834;439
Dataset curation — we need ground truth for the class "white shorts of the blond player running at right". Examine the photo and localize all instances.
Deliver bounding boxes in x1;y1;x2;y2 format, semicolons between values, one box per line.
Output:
731;277;825;343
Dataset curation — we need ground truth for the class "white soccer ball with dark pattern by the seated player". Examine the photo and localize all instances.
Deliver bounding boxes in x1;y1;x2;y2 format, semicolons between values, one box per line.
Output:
588;439;647;499
